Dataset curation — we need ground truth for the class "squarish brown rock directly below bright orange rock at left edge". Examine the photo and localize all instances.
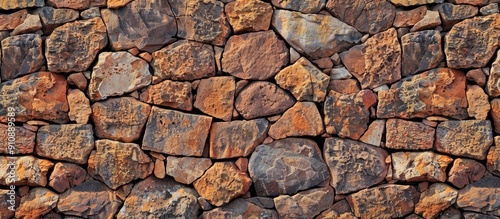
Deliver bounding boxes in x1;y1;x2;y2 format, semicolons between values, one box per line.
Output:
35;124;94;164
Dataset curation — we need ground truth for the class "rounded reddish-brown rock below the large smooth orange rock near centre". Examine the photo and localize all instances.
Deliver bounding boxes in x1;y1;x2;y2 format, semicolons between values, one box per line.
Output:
234;81;295;119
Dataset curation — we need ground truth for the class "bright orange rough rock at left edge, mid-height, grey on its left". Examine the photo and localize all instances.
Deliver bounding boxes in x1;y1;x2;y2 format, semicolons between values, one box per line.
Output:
0;72;69;123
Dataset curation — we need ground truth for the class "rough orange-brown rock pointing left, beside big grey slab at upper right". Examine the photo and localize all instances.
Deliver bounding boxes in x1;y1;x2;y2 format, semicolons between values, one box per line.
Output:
340;28;401;88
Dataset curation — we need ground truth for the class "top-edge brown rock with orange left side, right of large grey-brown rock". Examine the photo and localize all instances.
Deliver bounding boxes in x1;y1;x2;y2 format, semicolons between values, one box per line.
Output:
168;0;231;46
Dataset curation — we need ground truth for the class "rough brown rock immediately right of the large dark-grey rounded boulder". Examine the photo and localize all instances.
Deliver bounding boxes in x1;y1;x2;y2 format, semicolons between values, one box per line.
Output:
324;138;388;194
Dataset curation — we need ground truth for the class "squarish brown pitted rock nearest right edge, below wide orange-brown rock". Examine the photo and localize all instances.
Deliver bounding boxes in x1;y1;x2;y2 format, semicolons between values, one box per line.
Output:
435;120;493;160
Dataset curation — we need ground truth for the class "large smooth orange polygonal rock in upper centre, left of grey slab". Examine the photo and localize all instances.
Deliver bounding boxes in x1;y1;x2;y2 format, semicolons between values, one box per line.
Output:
222;30;289;80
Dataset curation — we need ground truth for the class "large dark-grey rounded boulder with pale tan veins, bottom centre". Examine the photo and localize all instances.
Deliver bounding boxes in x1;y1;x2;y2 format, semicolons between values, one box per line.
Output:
248;138;330;196
